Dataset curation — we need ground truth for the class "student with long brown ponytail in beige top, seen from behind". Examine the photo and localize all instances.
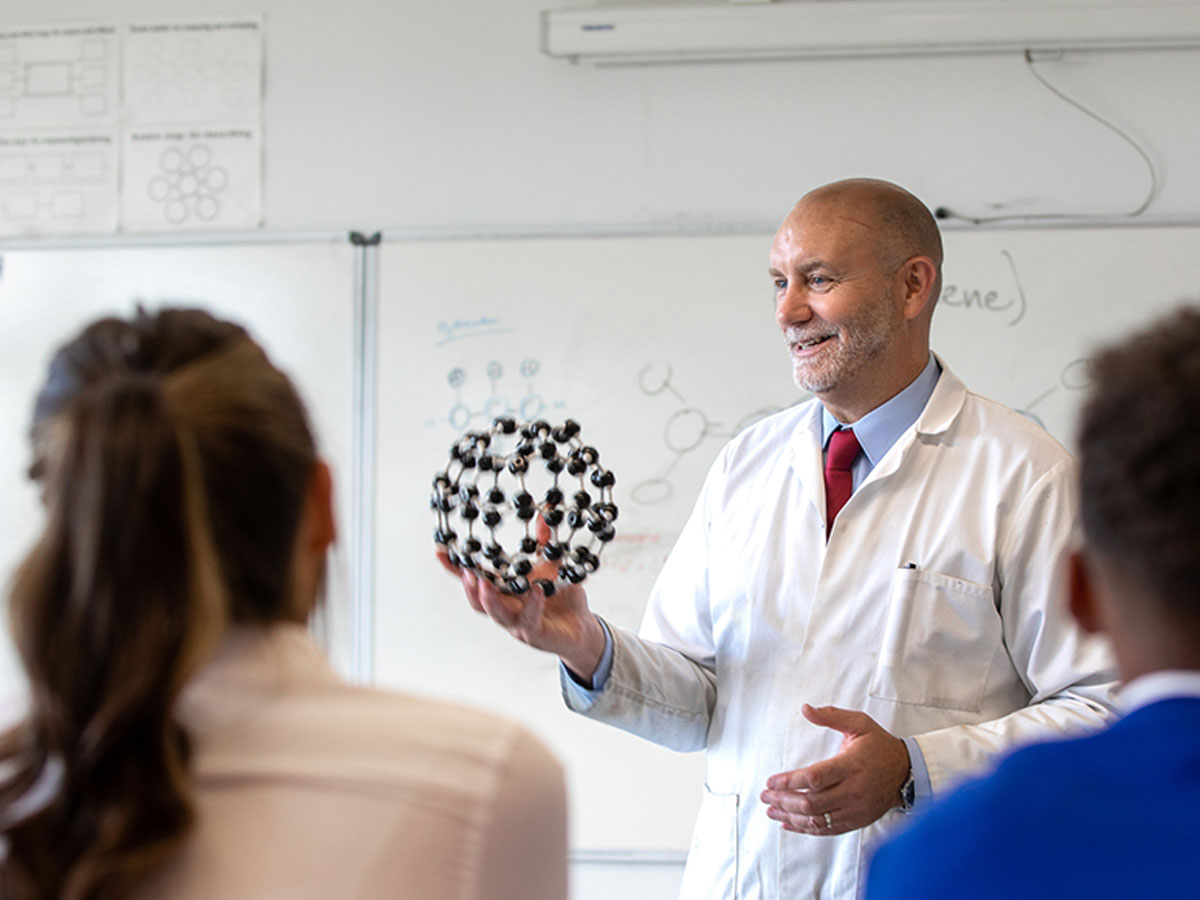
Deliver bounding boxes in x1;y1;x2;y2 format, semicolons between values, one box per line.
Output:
0;310;566;900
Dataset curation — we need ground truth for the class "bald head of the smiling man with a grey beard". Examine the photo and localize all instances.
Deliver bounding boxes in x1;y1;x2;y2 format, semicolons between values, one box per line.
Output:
770;179;942;422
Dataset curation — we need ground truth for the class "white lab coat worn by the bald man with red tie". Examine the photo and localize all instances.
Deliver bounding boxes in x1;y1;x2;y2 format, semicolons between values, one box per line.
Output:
564;360;1115;900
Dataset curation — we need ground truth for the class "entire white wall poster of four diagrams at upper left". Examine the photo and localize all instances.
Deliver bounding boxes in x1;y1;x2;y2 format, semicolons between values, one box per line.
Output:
0;16;263;238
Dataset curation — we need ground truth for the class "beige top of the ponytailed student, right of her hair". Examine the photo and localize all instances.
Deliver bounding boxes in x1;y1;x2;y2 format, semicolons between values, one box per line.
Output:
138;625;566;900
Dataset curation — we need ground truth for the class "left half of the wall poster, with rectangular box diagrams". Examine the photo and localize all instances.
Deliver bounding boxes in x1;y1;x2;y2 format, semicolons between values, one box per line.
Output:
0;24;120;236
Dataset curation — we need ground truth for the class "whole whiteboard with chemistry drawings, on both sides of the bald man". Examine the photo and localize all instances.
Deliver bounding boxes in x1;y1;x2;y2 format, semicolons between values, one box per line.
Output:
374;228;1200;854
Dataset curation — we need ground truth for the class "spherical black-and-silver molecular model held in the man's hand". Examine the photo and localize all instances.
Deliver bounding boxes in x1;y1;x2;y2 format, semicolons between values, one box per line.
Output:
430;416;617;596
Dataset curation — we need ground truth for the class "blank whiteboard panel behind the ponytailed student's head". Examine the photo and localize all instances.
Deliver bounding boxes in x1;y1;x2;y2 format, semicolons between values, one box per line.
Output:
0;241;356;692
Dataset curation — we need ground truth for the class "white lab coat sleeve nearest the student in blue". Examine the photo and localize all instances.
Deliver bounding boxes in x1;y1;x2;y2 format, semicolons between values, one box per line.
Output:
916;461;1117;798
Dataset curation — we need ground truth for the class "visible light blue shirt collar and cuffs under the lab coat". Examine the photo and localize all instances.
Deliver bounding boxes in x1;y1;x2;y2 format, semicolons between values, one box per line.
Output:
559;354;942;805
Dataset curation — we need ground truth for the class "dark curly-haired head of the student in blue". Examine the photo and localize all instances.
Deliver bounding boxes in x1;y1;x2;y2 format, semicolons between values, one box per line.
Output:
1072;307;1200;678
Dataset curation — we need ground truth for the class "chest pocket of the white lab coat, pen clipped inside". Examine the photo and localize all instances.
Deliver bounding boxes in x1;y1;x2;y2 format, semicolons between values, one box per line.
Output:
870;569;1002;712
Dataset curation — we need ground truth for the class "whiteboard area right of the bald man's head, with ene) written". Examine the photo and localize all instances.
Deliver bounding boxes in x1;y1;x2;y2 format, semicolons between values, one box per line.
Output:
932;227;1200;450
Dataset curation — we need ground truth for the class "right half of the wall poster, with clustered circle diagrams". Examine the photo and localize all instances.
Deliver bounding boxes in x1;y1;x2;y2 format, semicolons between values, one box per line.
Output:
122;17;263;232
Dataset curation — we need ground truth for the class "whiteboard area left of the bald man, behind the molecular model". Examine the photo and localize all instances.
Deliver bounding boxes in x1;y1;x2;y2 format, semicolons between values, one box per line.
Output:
374;238;796;851
